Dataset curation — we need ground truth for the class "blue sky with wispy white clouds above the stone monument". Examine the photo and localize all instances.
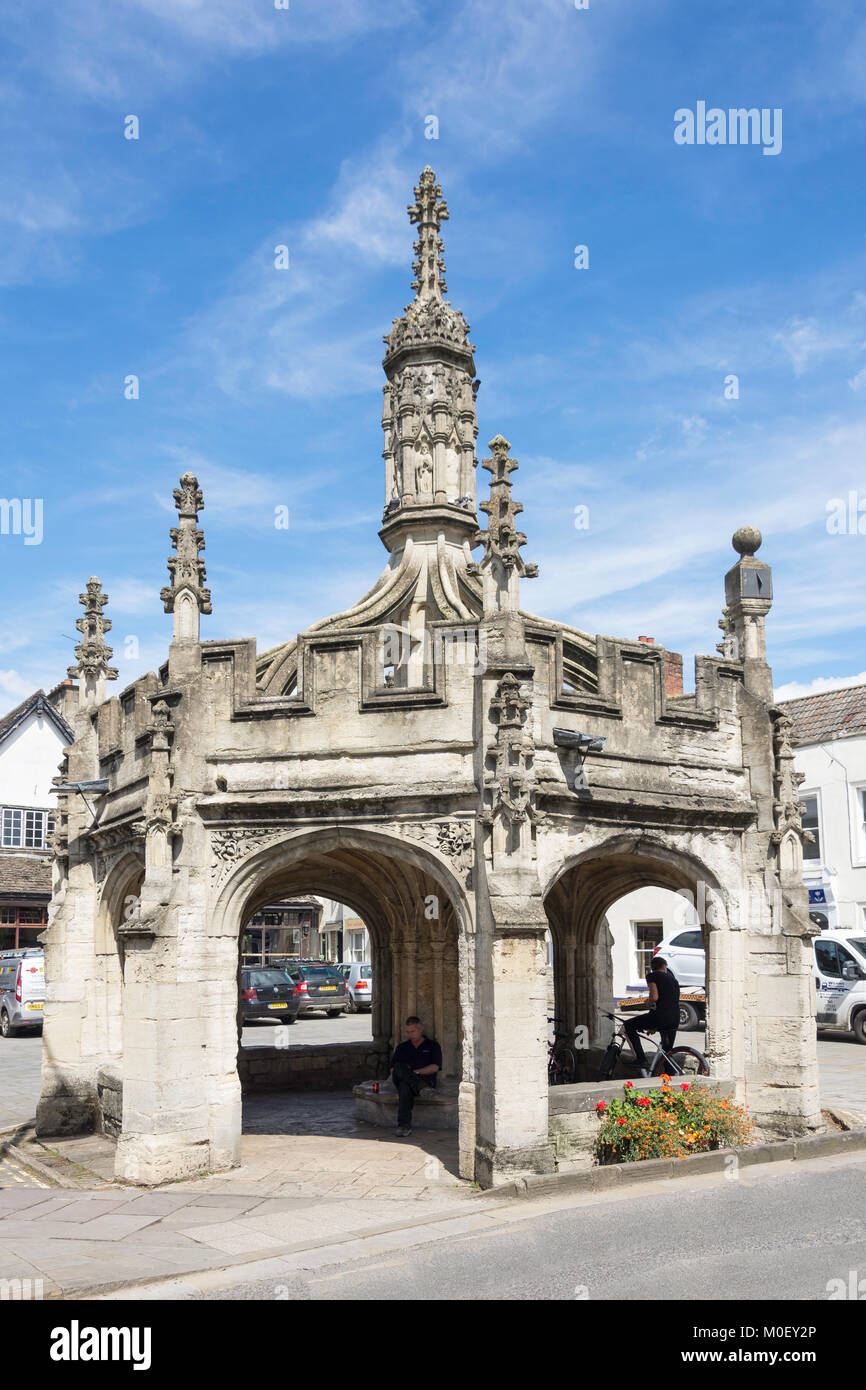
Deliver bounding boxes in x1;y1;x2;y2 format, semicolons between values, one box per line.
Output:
0;0;866;706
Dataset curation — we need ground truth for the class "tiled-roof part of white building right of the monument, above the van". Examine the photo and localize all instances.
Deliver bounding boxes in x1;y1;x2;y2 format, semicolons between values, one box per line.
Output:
783;685;866;931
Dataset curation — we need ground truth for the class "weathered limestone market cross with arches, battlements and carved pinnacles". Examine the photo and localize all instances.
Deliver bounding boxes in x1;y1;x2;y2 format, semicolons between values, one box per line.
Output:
39;170;820;1184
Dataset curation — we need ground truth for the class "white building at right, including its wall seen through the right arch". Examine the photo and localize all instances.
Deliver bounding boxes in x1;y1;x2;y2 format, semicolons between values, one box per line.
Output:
607;685;866;997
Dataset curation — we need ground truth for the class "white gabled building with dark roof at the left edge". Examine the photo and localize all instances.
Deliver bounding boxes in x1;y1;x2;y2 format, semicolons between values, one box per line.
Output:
0;681;75;949
